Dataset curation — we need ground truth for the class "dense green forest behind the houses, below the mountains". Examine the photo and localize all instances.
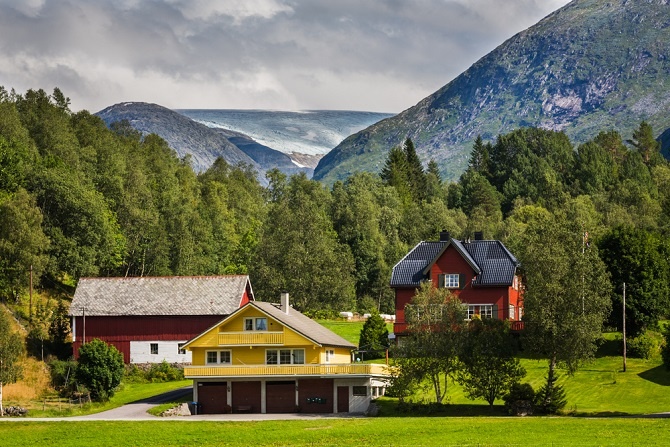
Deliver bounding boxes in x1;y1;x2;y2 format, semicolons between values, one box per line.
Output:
0;88;670;333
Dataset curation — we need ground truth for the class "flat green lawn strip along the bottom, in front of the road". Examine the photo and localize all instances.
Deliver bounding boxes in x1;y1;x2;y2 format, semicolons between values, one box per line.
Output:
0;417;670;447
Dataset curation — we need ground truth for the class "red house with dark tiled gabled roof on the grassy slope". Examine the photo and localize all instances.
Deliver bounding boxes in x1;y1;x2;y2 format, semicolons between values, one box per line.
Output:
391;232;523;335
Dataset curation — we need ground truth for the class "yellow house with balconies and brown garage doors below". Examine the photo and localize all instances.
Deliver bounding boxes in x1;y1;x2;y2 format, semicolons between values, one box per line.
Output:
183;294;387;414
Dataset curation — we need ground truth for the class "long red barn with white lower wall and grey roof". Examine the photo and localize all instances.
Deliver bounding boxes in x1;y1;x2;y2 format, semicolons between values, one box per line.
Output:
70;275;254;363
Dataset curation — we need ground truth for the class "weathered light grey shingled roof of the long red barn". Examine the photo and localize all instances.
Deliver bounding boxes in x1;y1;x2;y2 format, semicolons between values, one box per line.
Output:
70;275;253;316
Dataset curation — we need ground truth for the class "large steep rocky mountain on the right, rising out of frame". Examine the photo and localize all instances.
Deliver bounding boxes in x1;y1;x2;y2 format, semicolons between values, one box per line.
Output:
314;0;670;183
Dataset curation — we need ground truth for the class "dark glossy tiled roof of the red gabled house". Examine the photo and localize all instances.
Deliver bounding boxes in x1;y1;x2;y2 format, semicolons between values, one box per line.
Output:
391;239;519;287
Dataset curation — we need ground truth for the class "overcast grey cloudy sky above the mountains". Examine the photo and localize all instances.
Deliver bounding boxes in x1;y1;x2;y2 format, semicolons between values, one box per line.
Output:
0;0;569;113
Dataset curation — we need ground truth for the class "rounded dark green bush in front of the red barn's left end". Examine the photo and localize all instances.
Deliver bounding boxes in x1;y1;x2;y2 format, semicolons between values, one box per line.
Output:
76;339;124;401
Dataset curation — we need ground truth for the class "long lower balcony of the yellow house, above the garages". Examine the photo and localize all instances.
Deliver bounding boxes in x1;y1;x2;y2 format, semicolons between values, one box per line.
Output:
184;363;388;379
